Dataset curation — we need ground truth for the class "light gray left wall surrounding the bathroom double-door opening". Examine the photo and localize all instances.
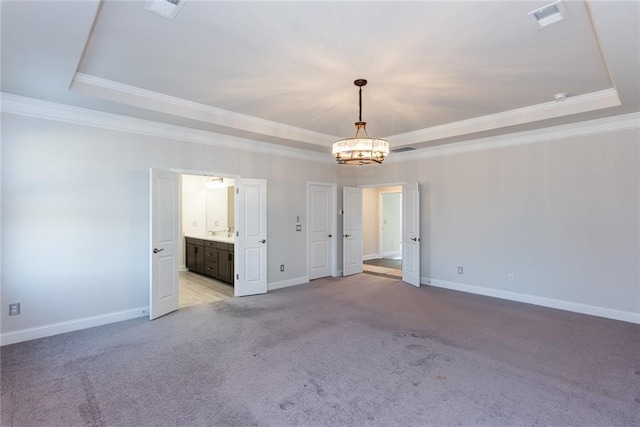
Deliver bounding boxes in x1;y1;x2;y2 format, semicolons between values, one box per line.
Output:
1;114;355;342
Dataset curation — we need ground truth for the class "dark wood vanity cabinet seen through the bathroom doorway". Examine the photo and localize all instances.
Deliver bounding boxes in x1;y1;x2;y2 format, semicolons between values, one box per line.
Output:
185;237;234;285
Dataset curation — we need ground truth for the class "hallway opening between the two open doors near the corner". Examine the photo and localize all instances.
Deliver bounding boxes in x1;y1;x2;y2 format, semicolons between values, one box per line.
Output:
362;186;402;279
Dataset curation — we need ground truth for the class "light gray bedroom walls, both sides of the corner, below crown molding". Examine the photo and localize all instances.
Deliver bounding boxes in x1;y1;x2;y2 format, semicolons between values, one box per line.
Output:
1;114;640;344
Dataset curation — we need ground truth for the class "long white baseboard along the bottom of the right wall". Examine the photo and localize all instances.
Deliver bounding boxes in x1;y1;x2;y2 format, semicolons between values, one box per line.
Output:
420;277;640;324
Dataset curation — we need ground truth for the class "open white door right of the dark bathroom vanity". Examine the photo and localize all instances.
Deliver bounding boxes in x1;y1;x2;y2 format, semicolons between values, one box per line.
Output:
234;179;267;297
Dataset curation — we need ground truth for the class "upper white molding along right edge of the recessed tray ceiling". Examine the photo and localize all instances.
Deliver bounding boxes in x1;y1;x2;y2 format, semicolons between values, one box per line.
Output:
385;89;622;148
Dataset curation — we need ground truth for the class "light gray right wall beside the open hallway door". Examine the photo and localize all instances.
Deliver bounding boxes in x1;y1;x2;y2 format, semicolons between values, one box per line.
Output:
358;125;640;323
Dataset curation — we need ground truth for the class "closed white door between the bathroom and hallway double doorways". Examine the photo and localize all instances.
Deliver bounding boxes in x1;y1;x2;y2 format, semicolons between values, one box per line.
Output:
307;184;336;280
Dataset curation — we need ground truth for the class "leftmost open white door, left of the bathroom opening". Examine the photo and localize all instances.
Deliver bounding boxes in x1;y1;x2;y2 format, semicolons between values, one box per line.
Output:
149;169;179;320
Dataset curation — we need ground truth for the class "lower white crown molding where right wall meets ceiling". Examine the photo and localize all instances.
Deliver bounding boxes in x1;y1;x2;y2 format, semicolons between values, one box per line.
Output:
385;113;640;163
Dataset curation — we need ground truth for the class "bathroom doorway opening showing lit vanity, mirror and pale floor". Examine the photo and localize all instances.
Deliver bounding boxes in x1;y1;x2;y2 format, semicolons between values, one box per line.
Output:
178;174;235;308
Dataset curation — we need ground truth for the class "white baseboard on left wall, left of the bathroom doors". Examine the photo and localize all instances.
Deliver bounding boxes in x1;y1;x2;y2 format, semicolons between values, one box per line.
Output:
0;307;149;345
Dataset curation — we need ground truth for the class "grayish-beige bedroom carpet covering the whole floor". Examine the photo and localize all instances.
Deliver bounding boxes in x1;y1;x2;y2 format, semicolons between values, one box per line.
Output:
0;274;640;427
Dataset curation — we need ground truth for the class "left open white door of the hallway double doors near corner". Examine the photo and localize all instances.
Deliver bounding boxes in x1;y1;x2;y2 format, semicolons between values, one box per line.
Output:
342;187;362;276
